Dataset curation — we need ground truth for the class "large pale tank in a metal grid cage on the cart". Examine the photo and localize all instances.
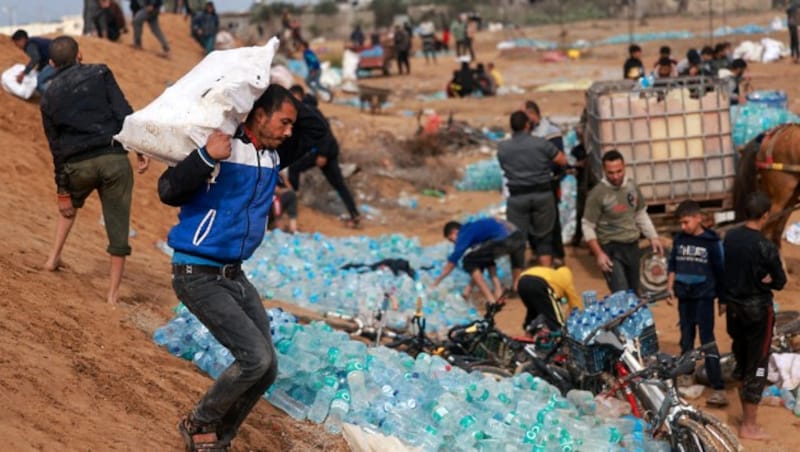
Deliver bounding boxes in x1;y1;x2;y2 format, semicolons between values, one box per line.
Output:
584;77;737;213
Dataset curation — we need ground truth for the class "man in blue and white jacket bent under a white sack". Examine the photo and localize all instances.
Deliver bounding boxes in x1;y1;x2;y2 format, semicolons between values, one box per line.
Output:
158;85;324;451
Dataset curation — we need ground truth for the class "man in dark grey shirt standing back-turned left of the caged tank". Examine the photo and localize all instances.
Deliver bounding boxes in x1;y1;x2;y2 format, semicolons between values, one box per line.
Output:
497;111;567;266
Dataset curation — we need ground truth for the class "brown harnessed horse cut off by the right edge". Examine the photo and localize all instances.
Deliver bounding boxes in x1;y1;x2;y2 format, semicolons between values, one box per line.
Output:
733;124;800;248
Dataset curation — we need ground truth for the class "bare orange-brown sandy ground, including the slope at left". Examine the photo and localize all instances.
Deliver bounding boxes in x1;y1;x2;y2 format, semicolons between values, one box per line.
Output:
0;10;800;451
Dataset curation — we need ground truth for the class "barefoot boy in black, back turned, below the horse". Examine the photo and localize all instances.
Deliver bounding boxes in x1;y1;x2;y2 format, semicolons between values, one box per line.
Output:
719;192;786;440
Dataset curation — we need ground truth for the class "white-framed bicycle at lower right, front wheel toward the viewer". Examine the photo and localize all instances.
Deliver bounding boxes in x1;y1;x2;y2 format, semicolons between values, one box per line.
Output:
583;295;742;452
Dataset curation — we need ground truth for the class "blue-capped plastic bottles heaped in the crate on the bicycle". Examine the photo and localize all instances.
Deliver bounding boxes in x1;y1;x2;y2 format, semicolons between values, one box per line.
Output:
567;290;653;341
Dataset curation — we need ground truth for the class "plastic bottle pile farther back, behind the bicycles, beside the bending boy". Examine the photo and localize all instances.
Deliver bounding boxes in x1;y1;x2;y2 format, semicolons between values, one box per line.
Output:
252;230;488;331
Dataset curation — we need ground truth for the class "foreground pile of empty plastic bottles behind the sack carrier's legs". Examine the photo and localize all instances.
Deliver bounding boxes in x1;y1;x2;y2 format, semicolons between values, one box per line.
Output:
154;307;669;451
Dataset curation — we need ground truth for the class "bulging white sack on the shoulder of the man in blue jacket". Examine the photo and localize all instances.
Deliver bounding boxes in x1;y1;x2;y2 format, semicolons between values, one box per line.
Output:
114;38;279;165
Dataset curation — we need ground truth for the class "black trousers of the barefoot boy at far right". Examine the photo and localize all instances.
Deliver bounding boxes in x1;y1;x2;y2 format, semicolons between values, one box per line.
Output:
725;303;775;404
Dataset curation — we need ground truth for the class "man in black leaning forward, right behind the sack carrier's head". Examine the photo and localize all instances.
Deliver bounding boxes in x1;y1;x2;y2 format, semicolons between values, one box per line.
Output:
289;85;361;227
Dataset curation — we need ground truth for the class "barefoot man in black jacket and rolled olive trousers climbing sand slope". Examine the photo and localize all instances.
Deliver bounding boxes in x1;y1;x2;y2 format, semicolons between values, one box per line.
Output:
40;36;150;303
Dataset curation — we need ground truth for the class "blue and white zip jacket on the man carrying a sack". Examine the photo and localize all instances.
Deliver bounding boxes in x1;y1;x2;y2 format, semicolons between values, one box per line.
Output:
158;127;280;264
